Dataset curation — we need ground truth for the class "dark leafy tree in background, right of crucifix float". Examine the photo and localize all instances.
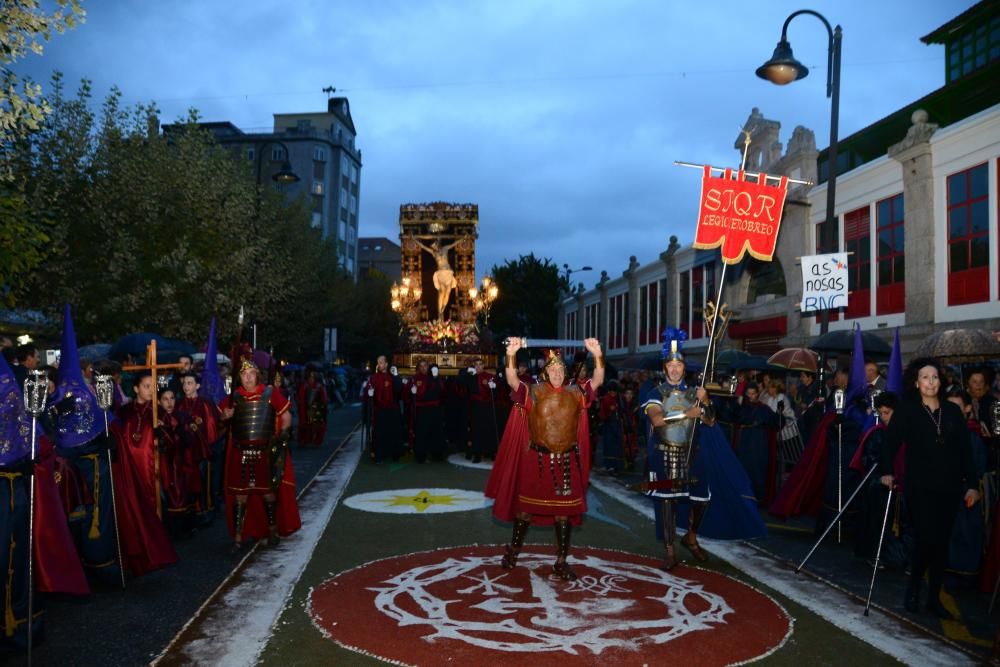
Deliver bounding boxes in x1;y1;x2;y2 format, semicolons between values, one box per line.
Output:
490;253;565;340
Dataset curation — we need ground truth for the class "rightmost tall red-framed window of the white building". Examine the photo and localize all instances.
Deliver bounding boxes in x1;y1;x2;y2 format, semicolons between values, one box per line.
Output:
947;163;990;306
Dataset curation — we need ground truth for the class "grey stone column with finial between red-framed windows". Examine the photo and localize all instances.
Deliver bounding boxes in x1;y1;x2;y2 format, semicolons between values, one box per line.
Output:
889;109;943;326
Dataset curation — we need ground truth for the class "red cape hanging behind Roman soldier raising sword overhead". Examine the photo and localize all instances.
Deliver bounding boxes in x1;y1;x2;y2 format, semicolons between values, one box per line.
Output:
485;386;590;526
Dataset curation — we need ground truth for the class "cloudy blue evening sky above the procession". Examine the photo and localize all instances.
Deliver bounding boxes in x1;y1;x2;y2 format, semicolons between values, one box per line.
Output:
15;0;974;287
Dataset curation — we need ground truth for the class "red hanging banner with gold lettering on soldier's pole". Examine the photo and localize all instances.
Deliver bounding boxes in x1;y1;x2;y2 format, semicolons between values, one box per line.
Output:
694;165;788;264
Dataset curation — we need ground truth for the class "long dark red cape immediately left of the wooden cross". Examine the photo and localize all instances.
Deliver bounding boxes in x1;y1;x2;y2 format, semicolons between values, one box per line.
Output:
111;401;177;575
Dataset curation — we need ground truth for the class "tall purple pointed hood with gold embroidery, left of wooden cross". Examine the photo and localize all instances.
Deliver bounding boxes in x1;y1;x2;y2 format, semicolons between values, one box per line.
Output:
49;303;104;449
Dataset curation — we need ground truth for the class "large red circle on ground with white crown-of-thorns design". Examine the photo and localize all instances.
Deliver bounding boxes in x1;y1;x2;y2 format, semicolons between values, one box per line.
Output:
309;546;792;667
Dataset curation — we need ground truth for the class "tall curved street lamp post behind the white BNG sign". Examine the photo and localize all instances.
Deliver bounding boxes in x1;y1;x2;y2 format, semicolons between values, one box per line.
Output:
757;9;842;333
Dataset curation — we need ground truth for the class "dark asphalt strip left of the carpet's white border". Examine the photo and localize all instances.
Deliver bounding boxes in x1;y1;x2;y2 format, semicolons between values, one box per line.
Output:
0;407;360;667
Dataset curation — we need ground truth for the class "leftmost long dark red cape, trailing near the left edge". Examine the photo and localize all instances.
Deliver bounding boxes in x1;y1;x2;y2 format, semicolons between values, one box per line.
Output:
32;437;90;595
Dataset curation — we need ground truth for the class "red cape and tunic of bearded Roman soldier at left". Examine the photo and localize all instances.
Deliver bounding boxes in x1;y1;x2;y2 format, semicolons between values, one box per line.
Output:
219;384;302;539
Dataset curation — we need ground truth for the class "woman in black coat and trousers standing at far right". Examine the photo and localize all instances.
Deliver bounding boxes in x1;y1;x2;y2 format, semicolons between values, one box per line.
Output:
881;357;979;618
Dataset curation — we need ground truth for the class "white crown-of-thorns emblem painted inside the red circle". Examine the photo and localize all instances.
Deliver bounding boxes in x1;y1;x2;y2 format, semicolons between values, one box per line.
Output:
369;552;733;655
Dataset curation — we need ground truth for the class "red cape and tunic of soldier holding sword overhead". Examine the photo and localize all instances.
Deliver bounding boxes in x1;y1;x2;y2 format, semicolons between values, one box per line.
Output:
485;383;594;526
